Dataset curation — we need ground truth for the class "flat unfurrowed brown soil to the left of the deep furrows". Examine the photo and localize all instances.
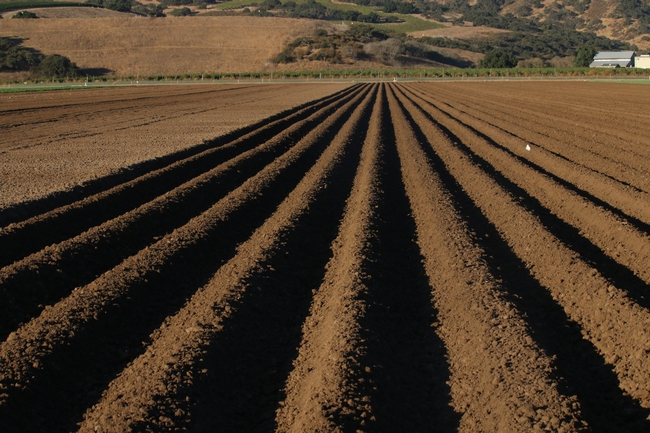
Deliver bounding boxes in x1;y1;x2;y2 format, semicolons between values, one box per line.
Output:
0;84;342;209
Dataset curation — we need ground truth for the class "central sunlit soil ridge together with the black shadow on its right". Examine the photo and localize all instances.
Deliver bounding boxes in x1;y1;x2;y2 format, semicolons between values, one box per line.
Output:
277;84;458;432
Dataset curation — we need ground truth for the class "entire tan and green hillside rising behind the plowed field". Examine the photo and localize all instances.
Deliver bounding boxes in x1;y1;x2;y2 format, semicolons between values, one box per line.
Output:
0;0;650;79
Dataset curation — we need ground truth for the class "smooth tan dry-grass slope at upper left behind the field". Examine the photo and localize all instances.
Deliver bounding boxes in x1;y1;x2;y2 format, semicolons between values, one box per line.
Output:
0;15;342;75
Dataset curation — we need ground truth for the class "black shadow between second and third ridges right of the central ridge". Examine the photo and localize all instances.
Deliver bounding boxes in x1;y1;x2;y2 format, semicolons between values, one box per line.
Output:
394;88;650;309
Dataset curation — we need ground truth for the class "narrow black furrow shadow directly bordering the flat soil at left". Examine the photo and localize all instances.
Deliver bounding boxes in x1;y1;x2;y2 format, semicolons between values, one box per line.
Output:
0;85;361;230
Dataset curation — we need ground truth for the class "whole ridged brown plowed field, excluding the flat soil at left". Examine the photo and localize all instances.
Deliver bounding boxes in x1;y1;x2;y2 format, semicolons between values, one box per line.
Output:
0;83;650;432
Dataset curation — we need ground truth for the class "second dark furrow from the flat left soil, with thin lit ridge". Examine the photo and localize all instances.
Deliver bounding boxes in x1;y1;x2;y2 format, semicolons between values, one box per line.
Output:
0;84;355;266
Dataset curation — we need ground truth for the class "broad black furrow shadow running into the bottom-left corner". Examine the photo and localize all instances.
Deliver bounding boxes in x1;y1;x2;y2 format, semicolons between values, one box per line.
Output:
0;85;370;432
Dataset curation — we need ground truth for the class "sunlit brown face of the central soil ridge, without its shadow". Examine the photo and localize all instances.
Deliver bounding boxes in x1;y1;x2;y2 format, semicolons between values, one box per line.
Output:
276;88;390;432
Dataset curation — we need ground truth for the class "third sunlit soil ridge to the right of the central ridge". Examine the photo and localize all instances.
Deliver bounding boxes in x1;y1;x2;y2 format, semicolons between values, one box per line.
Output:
398;84;650;292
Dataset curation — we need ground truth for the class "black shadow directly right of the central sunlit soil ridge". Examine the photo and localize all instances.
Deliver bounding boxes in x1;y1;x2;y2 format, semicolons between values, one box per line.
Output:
354;86;460;433
